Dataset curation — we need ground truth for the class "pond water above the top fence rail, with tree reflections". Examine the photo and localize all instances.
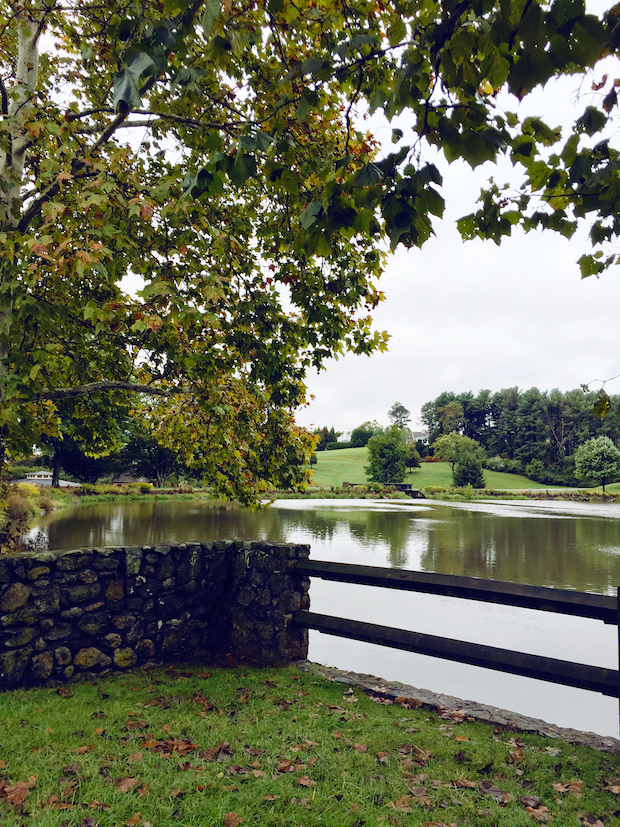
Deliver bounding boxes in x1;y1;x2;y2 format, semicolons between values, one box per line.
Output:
31;500;620;594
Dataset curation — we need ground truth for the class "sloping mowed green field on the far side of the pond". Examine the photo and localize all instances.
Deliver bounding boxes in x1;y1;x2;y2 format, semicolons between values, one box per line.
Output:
312;448;554;489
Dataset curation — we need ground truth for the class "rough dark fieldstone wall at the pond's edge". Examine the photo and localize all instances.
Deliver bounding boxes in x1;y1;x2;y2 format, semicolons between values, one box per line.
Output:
0;541;310;689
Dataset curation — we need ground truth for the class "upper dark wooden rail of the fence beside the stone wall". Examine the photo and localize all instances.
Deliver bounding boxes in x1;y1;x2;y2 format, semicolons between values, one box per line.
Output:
296;560;618;625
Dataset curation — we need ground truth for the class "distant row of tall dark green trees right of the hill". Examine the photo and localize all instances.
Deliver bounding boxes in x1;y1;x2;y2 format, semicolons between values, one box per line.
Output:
421;388;620;485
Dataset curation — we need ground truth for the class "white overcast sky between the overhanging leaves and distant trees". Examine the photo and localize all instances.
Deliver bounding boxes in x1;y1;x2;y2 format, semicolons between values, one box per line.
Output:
297;36;620;431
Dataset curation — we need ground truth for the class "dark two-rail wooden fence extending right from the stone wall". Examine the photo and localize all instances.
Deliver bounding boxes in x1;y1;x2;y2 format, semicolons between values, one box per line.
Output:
295;560;620;728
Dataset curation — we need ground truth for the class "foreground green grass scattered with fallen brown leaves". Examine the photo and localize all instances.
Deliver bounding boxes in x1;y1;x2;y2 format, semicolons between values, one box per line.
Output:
0;665;620;827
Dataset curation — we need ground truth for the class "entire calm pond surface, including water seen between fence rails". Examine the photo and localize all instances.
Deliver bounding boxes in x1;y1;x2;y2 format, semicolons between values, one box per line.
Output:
29;500;620;737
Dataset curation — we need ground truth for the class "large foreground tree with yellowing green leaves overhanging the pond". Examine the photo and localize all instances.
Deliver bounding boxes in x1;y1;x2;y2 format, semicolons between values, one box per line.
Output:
0;0;620;500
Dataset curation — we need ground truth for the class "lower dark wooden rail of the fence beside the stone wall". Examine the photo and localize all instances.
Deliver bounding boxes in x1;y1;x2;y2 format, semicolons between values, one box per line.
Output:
294;610;620;698
